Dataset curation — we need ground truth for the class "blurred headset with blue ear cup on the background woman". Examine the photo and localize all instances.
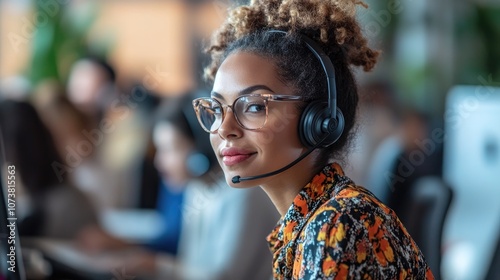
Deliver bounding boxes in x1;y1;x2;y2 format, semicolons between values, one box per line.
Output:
181;94;215;177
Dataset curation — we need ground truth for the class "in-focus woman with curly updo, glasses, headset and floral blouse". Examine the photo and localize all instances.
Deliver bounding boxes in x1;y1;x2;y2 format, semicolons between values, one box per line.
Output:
193;0;433;279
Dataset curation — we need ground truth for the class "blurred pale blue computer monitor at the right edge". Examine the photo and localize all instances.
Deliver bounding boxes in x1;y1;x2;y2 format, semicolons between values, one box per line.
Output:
443;85;500;280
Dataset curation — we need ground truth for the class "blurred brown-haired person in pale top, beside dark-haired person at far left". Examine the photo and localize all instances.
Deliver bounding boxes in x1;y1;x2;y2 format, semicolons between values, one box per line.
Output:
33;80;116;210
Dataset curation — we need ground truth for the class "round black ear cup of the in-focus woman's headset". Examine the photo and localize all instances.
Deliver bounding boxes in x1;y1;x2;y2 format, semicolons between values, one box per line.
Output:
299;101;344;148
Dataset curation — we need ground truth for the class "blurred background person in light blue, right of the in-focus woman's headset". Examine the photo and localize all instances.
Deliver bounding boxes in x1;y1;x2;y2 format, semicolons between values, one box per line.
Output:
356;81;402;203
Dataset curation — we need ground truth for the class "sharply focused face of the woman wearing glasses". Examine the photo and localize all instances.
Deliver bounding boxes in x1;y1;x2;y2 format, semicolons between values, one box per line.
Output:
210;52;305;187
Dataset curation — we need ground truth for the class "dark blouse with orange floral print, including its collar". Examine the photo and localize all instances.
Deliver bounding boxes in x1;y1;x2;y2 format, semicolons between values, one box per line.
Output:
267;163;434;280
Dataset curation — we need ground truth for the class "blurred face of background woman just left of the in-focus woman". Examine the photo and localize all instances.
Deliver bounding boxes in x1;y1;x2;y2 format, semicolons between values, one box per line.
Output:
153;122;194;186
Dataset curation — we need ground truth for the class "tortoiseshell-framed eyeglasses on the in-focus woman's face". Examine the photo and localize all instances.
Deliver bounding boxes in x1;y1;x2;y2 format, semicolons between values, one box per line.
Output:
193;94;304;133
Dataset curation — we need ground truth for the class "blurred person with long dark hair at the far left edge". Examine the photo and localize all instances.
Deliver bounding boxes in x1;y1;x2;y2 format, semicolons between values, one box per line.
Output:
0;100;97;239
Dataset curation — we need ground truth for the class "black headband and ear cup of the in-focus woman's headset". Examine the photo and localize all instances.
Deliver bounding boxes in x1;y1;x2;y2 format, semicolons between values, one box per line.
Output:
268;30;345;148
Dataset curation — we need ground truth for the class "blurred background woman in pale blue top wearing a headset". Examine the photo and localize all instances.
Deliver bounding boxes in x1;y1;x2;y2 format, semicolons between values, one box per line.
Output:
82;95;279;280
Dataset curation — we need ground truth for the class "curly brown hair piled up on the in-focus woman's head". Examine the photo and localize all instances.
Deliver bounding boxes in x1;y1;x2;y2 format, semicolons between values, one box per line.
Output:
205;0;379;165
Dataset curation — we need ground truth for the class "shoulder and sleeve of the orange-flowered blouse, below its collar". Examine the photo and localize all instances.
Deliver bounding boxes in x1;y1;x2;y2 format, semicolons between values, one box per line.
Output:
301;185;432;279
